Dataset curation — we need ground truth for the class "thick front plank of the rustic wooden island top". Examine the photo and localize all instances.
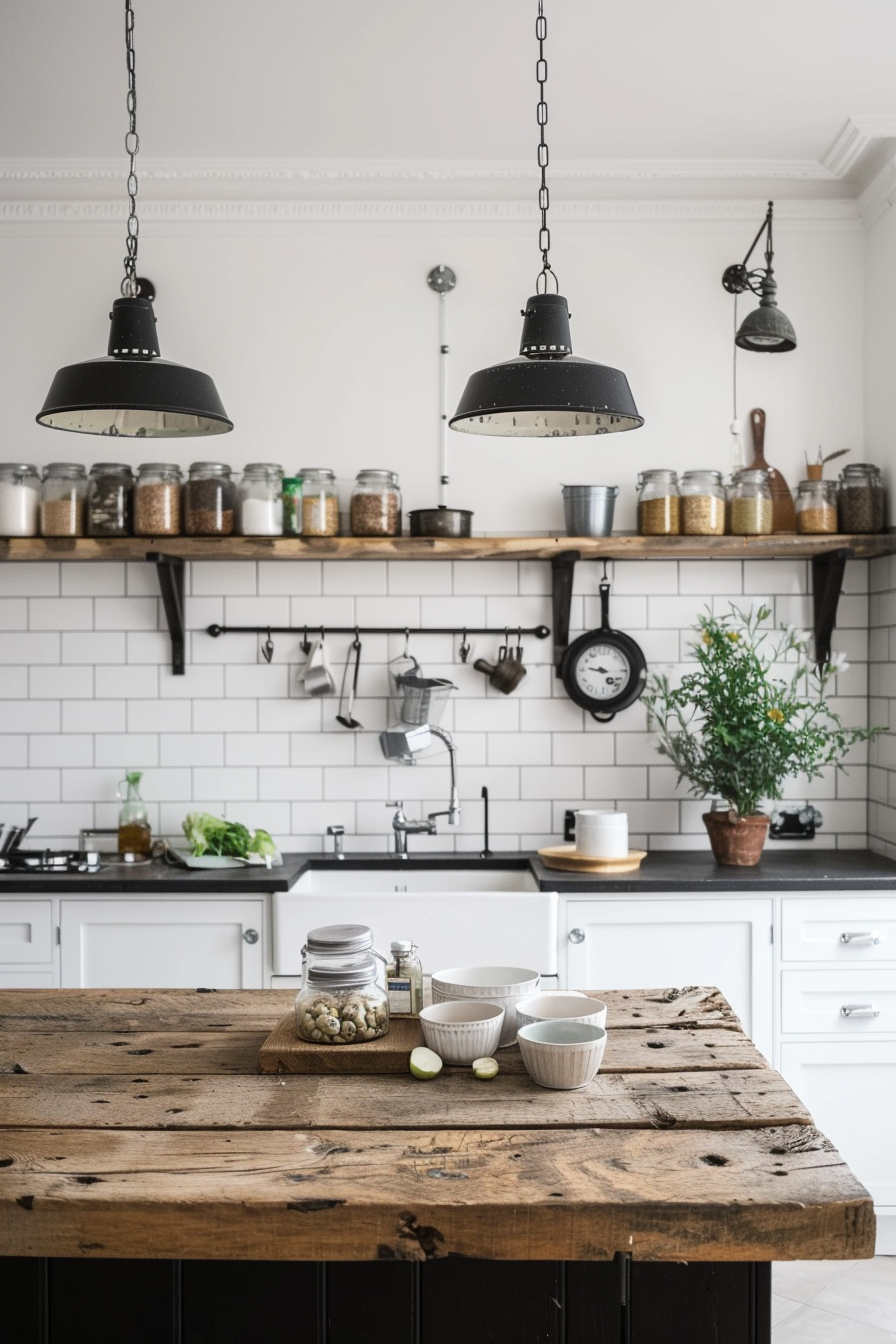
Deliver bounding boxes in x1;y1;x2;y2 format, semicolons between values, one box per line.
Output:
0;1126;875;1261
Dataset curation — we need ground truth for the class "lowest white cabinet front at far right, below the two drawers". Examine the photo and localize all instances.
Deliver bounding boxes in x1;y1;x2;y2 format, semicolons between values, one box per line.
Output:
780;1040;896;1206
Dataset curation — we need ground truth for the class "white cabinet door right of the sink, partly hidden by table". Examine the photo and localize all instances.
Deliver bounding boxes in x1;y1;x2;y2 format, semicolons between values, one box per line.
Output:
567;896;774;1059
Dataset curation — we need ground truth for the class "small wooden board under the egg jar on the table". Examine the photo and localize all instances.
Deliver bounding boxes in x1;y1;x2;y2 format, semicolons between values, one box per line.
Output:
258;1009;423;1074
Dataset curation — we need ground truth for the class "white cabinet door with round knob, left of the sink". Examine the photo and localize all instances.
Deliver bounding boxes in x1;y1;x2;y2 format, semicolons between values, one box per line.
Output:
60;898;265;989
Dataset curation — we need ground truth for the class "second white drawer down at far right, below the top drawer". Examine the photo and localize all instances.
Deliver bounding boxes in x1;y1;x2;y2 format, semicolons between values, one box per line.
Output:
780;968;896;1036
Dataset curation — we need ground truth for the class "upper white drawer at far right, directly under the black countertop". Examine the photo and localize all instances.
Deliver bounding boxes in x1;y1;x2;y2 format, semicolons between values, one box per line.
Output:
780;894;896;964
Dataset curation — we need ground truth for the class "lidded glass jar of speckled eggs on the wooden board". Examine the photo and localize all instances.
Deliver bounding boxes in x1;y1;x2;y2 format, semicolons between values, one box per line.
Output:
296;925;388;1046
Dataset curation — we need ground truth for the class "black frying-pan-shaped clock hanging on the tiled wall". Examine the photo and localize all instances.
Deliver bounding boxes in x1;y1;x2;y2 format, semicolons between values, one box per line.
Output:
560;578;647;723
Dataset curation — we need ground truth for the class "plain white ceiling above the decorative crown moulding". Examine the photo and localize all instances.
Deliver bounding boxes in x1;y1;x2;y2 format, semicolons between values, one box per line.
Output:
0;0;896;195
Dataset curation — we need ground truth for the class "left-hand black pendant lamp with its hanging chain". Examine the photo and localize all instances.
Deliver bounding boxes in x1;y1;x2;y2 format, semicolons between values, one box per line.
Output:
38;0;234;438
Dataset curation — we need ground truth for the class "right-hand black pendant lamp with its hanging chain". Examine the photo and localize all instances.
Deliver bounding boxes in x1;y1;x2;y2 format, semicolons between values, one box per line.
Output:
449;0;643;438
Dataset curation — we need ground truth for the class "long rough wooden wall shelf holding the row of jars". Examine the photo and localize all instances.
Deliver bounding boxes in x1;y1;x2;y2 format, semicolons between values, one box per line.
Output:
0;531;896;560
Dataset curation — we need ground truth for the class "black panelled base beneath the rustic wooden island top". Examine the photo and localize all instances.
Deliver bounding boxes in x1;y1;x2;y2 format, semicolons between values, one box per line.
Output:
0;1255;771;1344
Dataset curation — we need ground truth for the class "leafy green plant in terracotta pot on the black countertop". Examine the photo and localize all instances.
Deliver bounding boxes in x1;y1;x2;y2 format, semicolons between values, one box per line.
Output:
643;603;883;866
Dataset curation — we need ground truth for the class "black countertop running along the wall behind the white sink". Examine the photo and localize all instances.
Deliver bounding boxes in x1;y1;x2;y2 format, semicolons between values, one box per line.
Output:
0;843;896;896
